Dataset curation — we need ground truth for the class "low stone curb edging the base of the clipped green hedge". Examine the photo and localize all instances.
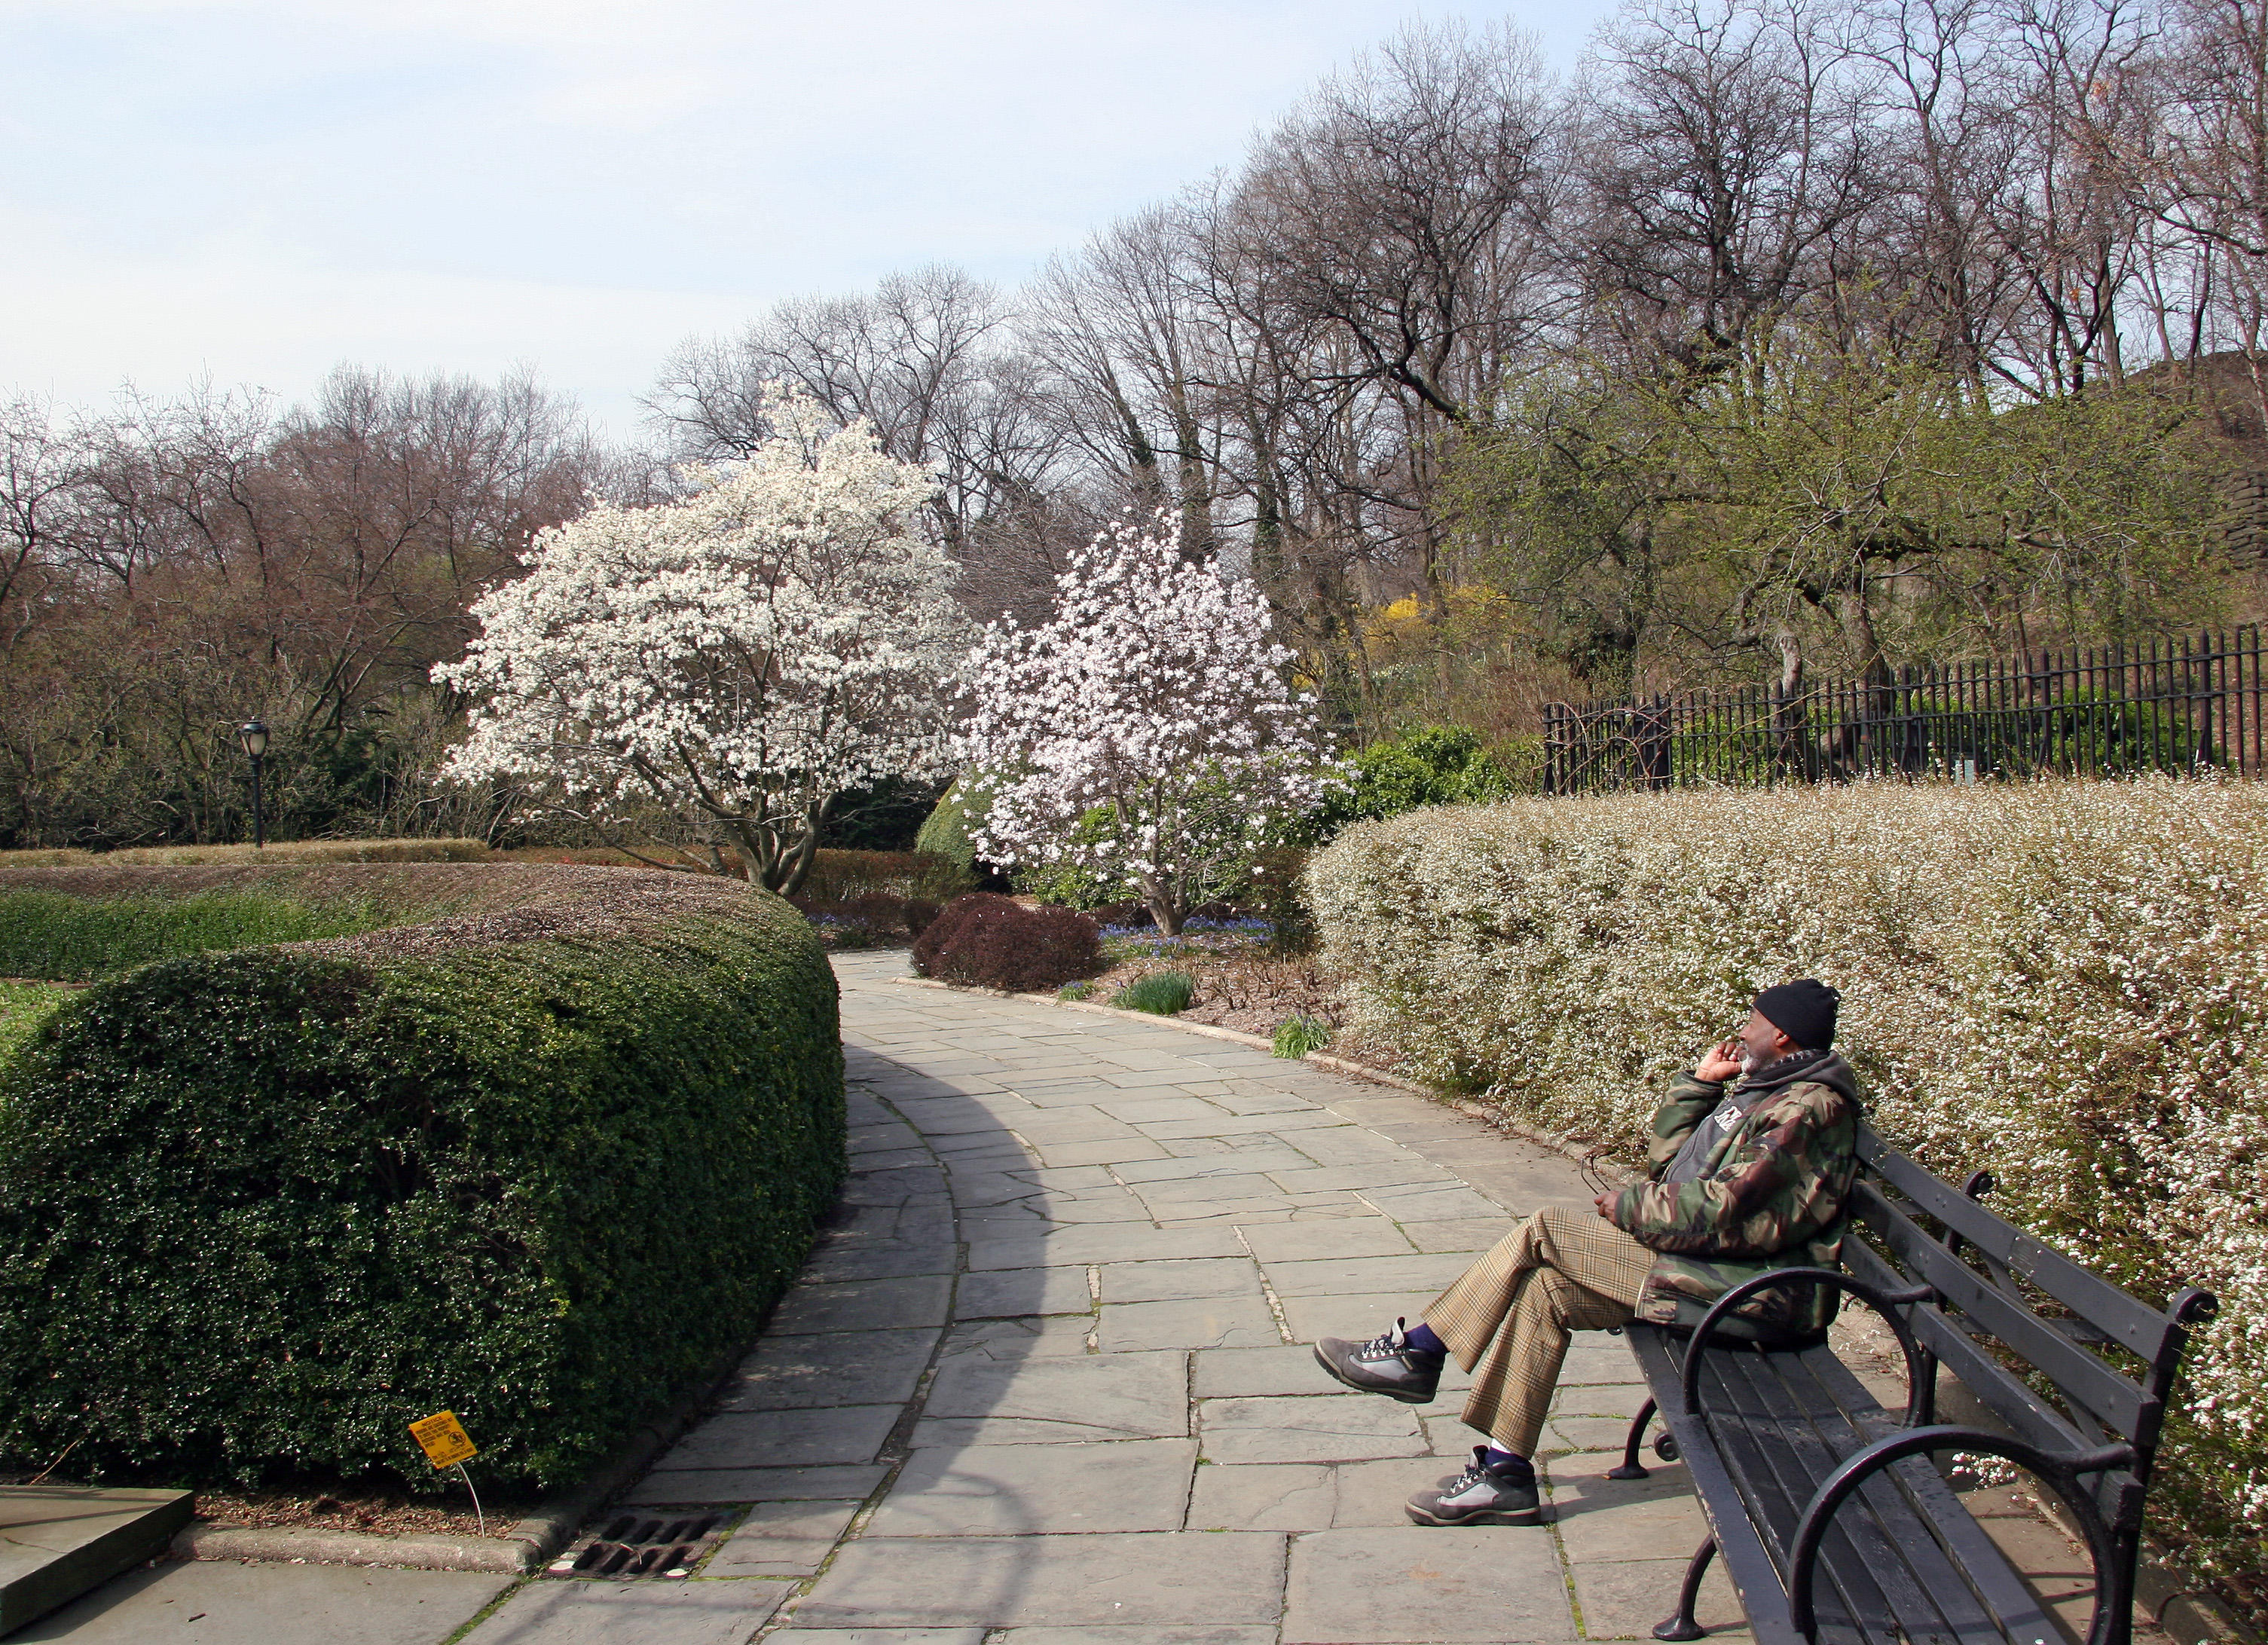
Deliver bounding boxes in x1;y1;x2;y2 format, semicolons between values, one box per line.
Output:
173;1348;748;1577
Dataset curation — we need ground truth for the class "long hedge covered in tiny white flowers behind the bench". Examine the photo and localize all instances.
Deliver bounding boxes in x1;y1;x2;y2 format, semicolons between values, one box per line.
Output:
1307;781;2268;1582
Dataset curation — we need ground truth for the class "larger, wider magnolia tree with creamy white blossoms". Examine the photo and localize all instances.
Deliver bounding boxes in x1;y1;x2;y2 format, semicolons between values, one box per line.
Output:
436;390;966;891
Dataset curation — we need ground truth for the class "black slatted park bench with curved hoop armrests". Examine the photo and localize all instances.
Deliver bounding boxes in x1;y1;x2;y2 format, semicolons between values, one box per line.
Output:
1608;1127;2218;1645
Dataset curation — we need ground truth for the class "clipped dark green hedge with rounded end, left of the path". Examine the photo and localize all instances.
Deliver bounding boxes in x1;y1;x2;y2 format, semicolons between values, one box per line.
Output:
0;864;844;1486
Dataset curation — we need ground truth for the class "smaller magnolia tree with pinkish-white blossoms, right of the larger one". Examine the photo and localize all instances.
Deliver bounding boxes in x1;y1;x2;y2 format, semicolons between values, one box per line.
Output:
957;512;1331;935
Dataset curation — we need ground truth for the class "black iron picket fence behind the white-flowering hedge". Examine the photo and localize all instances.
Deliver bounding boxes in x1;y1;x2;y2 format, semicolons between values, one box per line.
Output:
1545;626;2268;794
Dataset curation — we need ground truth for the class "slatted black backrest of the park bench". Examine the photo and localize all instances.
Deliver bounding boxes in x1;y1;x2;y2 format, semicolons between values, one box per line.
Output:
1844;1125;2218;1533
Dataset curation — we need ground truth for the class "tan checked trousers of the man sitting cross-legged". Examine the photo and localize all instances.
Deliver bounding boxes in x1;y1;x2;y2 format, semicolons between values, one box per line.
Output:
1424;1205;1653;1457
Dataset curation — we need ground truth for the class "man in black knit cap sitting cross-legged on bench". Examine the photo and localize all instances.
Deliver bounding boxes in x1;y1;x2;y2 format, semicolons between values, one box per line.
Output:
1316;978;1860;1524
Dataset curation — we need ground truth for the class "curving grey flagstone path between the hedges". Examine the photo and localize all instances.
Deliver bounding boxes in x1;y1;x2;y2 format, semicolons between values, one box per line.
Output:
456;956;1740;1645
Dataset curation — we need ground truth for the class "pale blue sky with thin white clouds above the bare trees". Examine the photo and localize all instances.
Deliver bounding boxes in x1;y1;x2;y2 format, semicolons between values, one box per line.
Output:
0;0;1610;438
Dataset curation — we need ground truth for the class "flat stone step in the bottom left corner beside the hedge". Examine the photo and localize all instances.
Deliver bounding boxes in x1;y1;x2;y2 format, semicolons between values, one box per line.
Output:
0;1486;195;1634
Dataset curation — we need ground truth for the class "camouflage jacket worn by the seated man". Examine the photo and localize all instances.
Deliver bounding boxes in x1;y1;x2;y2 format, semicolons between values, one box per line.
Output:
1612;1050;1860;1339
